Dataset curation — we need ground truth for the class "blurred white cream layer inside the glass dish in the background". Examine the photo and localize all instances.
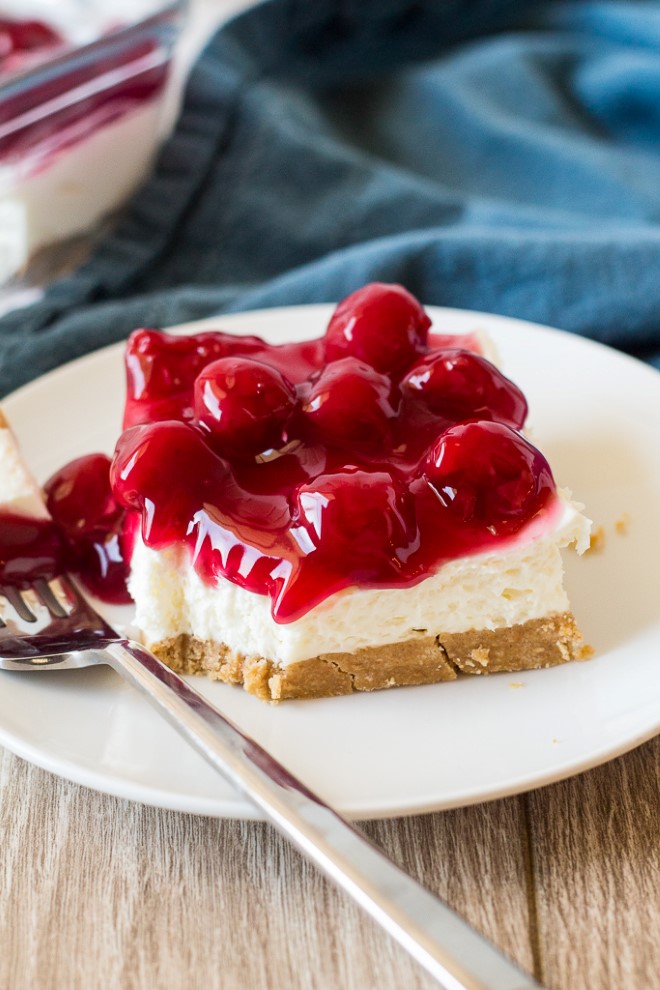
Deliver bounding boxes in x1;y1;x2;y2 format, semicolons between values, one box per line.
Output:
0;98;161;283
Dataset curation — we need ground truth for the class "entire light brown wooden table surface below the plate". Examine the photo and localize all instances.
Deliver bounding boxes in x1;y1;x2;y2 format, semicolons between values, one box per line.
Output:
0;738;660;990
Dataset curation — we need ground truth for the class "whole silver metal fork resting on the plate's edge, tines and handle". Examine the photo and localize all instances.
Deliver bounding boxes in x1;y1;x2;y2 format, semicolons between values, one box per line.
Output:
0;575;542;990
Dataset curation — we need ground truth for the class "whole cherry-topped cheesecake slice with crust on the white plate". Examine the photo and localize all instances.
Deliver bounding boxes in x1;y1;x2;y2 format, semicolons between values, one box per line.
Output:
112;285;590;700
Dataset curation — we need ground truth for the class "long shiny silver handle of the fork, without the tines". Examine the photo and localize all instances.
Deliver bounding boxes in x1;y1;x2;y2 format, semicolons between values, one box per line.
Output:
104;640;543;990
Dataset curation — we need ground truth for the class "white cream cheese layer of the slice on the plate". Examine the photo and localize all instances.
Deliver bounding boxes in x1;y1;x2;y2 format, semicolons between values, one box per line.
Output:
130;493;591;666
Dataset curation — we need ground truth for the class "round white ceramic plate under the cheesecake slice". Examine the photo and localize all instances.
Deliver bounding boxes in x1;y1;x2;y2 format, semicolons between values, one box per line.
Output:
0;306;660;818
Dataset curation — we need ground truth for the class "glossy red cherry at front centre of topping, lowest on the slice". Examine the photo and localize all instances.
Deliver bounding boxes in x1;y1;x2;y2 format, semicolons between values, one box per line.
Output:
293;466;416;571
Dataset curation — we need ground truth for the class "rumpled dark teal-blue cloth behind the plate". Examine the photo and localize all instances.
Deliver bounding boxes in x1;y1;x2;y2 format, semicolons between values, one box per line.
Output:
0;0;660;394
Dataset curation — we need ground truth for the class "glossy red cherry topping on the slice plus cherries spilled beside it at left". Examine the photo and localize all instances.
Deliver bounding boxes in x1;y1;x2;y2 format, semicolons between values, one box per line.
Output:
7;283;556;622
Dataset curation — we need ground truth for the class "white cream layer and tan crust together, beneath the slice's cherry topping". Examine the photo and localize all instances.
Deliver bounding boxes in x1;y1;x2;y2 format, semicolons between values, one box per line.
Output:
130;499;588;700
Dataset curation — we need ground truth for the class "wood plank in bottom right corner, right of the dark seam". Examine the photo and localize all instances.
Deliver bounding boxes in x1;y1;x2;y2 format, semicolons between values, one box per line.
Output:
526;738;660;990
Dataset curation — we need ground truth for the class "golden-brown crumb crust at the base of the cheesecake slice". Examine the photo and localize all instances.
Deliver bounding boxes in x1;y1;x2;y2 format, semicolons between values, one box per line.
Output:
149;612;591;701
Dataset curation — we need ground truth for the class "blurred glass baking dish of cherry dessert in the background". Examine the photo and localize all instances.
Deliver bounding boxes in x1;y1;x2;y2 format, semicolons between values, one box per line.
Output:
0;0;185;286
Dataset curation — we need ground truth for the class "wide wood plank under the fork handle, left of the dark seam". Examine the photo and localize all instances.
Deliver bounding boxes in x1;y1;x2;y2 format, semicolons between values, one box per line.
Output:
0;753;532;990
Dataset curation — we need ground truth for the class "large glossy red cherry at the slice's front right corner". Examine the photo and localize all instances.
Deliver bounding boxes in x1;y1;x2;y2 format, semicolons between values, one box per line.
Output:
424;422;554;535
